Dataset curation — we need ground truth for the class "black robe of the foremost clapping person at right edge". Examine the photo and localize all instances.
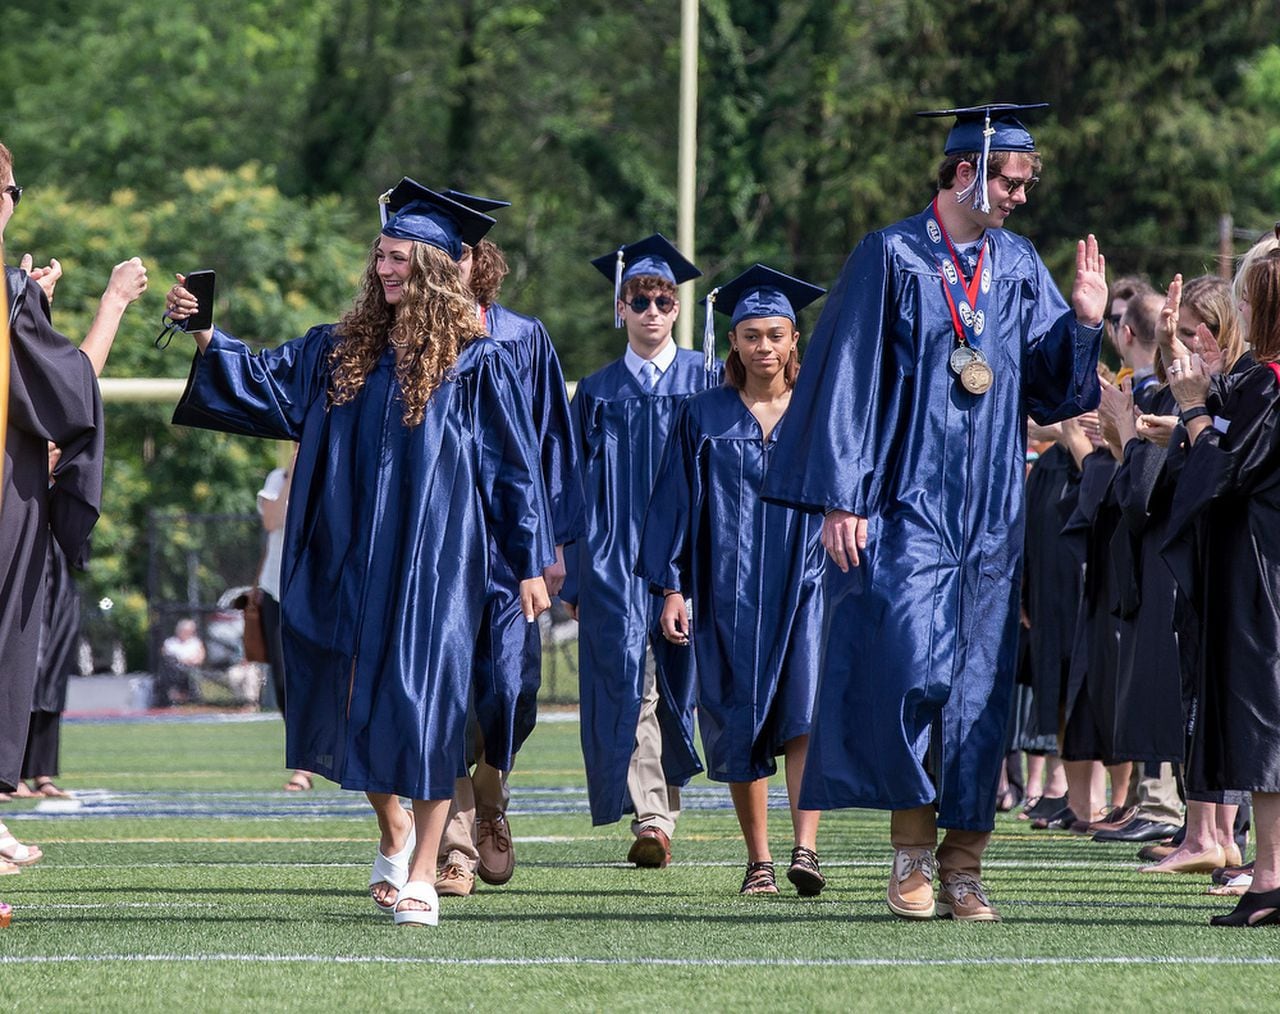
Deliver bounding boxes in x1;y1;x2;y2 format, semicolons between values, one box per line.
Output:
1165;364;1280;793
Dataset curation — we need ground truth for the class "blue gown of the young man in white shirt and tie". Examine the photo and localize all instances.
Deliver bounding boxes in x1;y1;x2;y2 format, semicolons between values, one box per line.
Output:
561;350;721;825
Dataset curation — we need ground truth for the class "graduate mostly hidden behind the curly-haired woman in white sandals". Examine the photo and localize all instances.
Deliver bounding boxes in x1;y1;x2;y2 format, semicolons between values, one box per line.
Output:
435;189;582;895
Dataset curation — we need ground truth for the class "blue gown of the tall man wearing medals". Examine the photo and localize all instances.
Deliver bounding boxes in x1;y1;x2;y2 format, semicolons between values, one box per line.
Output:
764;213;1101;831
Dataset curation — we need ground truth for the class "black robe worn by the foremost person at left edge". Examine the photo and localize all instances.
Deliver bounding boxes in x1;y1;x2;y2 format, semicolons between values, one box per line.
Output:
0;271;104;790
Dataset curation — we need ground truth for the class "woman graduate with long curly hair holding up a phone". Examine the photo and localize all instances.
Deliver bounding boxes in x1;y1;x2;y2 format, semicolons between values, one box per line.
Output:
169;179;554;924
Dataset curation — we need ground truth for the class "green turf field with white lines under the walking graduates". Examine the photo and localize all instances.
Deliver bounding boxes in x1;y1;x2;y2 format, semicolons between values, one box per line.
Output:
0;722;1280;1011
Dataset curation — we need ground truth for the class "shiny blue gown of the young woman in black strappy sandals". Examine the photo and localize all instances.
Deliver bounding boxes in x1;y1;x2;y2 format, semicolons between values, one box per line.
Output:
636;387;824;782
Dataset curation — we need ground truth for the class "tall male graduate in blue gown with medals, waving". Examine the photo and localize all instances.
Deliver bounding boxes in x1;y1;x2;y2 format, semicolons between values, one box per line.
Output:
764;106;1106;921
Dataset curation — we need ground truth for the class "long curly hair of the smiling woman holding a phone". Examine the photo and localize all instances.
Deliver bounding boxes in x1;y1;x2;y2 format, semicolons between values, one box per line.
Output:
329;239;484;426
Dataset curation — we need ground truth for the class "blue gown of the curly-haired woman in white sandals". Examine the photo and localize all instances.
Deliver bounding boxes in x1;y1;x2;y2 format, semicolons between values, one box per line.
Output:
174;325;553;799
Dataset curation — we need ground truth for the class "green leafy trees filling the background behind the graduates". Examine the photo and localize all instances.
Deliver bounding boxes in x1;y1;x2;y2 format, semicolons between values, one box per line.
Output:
0;0;1280;667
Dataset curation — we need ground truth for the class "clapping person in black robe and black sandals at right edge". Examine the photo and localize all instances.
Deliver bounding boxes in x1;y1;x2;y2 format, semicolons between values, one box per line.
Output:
1162;250;1280;927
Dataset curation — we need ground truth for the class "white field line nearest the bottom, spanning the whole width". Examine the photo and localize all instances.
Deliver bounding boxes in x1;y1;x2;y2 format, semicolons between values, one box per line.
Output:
0;954;1280;968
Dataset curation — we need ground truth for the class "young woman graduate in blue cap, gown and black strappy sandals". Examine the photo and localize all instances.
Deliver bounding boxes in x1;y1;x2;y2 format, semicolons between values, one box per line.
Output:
636;264;826;895
